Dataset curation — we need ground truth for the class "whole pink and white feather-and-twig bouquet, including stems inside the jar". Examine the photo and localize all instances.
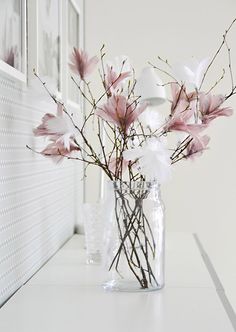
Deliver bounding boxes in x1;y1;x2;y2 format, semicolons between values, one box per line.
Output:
30;20;236;288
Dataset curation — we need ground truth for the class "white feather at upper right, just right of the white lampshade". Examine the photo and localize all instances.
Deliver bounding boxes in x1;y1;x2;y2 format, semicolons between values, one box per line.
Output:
173;58;210;89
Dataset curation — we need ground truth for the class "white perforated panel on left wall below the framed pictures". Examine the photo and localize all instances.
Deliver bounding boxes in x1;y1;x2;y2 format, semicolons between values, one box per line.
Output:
0;74;76;305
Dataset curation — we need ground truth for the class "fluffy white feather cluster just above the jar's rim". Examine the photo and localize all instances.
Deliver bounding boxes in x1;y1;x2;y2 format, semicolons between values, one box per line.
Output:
123;138;171;183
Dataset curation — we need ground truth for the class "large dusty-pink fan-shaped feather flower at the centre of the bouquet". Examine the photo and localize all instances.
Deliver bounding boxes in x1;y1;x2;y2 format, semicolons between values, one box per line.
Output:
96;95;147;132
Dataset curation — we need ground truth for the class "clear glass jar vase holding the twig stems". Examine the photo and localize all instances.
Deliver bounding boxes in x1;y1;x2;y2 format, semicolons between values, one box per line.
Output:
103;181;164;291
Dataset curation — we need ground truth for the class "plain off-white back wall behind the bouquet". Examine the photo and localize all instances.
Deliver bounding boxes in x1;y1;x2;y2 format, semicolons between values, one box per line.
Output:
85;0;236;309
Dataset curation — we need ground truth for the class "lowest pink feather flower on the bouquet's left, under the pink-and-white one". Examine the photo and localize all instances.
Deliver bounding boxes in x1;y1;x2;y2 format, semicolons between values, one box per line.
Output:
40;140;80;163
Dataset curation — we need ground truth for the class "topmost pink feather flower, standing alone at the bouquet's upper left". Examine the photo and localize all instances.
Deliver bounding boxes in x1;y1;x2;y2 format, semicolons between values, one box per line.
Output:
69;47;98;80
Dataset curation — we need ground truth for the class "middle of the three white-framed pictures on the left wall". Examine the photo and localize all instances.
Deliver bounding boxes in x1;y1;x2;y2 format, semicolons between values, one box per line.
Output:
37;0;61;91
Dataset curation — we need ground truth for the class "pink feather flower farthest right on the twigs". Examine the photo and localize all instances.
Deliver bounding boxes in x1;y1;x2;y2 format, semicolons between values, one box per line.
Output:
199;93;233;124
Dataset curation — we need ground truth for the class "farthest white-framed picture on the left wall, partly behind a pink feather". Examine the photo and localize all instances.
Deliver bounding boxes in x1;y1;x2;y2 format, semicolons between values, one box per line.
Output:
67;0;81;104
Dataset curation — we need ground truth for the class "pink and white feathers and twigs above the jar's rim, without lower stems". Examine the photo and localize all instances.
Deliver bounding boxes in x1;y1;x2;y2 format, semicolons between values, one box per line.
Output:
30;22;236;182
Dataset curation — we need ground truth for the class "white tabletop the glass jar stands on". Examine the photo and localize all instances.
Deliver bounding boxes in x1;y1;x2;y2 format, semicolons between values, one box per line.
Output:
0;233;234;332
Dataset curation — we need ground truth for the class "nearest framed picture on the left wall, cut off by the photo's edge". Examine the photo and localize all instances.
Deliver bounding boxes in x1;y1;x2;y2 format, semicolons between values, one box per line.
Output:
0;0;27;81
